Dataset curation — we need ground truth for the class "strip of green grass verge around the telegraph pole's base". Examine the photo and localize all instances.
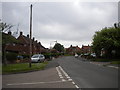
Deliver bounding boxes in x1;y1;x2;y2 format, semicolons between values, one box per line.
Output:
2;61;48;74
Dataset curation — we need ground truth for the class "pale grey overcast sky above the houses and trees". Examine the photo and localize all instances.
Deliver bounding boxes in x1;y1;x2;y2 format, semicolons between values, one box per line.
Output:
2;1;118;48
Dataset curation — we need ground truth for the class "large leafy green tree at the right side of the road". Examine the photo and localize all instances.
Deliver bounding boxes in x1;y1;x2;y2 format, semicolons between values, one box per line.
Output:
92;25;120;58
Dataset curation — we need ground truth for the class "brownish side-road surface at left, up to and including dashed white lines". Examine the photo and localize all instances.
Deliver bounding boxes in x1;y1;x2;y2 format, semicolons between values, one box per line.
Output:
2;60;77;88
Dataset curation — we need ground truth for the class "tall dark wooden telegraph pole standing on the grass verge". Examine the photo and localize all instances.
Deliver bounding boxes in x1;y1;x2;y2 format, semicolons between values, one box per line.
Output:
29;4;32;68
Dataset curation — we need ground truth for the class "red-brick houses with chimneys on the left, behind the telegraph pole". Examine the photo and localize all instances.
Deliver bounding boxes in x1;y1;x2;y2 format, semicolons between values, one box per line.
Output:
6;32;47;55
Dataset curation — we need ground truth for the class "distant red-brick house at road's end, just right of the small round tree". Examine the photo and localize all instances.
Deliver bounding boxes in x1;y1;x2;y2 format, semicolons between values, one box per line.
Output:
66;45;81;55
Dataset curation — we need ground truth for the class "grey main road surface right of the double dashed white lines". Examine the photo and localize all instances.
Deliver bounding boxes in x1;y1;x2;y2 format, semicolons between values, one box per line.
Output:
57;56;118;88
